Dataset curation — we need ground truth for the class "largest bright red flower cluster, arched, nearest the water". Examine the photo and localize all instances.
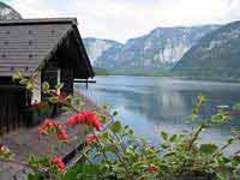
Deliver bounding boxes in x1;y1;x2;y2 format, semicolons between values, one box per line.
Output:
66;111;101;131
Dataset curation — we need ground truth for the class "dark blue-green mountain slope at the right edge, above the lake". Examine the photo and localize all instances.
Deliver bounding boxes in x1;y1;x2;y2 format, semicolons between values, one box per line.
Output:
173;21;240;80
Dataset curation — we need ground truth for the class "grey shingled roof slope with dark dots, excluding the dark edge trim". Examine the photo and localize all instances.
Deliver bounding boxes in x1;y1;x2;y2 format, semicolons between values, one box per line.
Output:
0;23;71;76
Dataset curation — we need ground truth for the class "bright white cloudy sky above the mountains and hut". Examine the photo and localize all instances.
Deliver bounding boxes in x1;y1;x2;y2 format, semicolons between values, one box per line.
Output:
3;0;240;42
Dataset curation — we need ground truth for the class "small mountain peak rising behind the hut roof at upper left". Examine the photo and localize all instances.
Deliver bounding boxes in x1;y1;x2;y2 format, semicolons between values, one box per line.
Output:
0;2;22;21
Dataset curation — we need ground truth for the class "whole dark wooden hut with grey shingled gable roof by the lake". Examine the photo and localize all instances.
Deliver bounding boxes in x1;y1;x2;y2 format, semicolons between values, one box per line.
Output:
0;18;94;134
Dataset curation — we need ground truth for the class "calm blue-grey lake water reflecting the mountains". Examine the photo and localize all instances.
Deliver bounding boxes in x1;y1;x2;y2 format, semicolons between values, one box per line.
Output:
76;76;240;151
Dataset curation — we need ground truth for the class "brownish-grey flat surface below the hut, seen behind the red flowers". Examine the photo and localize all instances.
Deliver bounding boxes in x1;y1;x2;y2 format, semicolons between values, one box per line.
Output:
0;94;109;179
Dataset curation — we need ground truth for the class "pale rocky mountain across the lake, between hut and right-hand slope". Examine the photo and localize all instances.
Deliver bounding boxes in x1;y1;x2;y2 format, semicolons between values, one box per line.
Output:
84;25;219;72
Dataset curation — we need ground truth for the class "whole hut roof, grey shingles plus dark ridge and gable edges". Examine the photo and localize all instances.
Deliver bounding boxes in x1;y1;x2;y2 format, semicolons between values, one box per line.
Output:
0;18;94;78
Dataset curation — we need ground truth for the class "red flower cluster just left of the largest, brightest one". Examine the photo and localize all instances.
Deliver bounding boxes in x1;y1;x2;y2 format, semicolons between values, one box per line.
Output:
38;119;68;142
